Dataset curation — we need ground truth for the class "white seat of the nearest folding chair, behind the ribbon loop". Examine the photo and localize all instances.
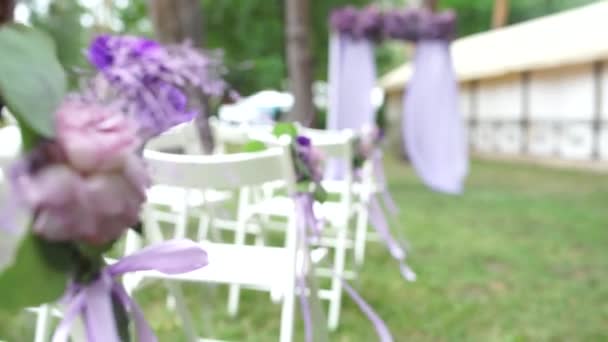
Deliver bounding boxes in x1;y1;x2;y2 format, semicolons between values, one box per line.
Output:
137;242;293;298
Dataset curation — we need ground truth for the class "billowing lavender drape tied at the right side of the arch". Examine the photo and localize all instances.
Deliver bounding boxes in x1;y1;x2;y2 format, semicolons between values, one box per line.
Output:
402;40;468;194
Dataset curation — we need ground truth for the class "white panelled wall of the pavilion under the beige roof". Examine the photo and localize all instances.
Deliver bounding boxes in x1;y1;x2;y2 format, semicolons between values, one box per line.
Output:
387;60;608;161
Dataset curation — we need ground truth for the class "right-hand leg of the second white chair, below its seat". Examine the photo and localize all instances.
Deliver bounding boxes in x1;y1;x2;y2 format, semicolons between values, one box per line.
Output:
327;225;347;330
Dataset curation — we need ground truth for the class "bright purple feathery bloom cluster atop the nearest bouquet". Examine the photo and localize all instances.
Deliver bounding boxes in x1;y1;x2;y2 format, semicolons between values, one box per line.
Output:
88;35;226;140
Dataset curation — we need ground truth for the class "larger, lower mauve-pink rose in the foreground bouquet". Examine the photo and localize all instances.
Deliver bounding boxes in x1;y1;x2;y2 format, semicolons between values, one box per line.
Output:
17;155;148;245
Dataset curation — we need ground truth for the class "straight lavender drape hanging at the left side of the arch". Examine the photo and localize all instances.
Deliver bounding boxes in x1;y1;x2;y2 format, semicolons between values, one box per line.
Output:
325;33;376;179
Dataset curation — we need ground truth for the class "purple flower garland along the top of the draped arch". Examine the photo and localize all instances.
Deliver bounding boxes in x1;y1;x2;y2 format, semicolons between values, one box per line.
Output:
330;5;456;42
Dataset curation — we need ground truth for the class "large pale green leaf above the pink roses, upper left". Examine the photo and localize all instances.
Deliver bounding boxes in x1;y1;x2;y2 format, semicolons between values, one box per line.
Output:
0;24;66;138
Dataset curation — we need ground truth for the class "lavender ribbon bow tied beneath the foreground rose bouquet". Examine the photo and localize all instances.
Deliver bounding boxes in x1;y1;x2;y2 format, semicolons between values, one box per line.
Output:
53;239;208;342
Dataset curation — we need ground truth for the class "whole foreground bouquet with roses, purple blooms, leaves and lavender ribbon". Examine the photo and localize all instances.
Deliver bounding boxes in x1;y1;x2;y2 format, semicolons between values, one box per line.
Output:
0;25;230;342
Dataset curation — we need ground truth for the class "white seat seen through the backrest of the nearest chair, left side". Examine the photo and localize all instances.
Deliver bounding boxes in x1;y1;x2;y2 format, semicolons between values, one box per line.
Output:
147;185;232;211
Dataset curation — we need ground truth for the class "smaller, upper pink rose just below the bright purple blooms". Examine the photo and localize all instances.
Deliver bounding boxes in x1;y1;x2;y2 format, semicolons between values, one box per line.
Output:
55;99;140;173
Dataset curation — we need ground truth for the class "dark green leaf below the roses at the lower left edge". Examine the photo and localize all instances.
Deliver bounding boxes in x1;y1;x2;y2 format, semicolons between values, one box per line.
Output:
0;234;73;312
